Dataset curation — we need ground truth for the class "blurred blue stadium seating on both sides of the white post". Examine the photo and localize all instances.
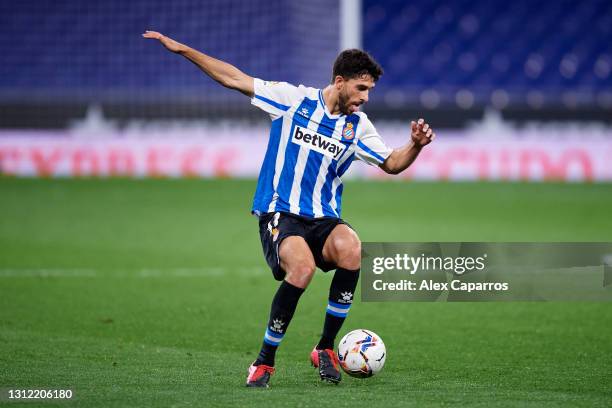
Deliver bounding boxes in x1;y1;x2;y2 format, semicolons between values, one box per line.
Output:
0;0;612;108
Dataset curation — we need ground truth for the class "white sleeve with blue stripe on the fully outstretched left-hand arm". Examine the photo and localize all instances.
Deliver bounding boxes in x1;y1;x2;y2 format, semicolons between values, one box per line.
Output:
251;78;300;120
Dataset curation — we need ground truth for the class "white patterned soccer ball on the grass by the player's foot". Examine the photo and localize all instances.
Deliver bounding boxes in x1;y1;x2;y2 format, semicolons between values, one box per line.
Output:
338;329;387;378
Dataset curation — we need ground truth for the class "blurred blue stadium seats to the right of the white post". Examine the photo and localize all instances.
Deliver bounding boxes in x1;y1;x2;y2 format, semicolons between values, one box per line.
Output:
363;0;612;108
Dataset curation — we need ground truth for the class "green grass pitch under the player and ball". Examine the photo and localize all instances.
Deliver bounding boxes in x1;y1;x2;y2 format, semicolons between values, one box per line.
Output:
0;178;612;407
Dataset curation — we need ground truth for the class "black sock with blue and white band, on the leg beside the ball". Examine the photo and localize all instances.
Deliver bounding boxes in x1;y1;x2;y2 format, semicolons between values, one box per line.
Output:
317;268;359;350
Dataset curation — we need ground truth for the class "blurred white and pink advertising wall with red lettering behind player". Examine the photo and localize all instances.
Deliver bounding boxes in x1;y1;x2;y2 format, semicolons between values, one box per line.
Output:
0;112;612;181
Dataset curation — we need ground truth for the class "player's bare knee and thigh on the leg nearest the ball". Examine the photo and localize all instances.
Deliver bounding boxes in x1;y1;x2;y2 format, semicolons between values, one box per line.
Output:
323;224;361;270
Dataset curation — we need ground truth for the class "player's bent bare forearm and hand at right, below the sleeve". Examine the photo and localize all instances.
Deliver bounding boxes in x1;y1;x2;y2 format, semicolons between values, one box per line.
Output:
380;119;436;174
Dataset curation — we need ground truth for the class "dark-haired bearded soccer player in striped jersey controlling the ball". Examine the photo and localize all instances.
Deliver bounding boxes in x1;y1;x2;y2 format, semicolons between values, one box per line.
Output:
143;31;435;387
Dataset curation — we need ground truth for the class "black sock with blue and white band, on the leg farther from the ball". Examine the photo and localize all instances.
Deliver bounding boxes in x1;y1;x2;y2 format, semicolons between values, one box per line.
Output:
255;281;304;367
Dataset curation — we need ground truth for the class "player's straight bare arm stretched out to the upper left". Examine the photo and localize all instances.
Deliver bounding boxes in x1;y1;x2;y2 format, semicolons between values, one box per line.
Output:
142;31;255;97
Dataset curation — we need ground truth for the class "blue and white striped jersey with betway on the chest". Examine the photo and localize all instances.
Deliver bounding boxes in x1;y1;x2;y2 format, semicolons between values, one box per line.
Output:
251;79;392;218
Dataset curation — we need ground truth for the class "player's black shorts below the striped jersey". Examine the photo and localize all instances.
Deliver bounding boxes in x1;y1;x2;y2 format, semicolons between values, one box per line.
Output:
259;212;352;281
